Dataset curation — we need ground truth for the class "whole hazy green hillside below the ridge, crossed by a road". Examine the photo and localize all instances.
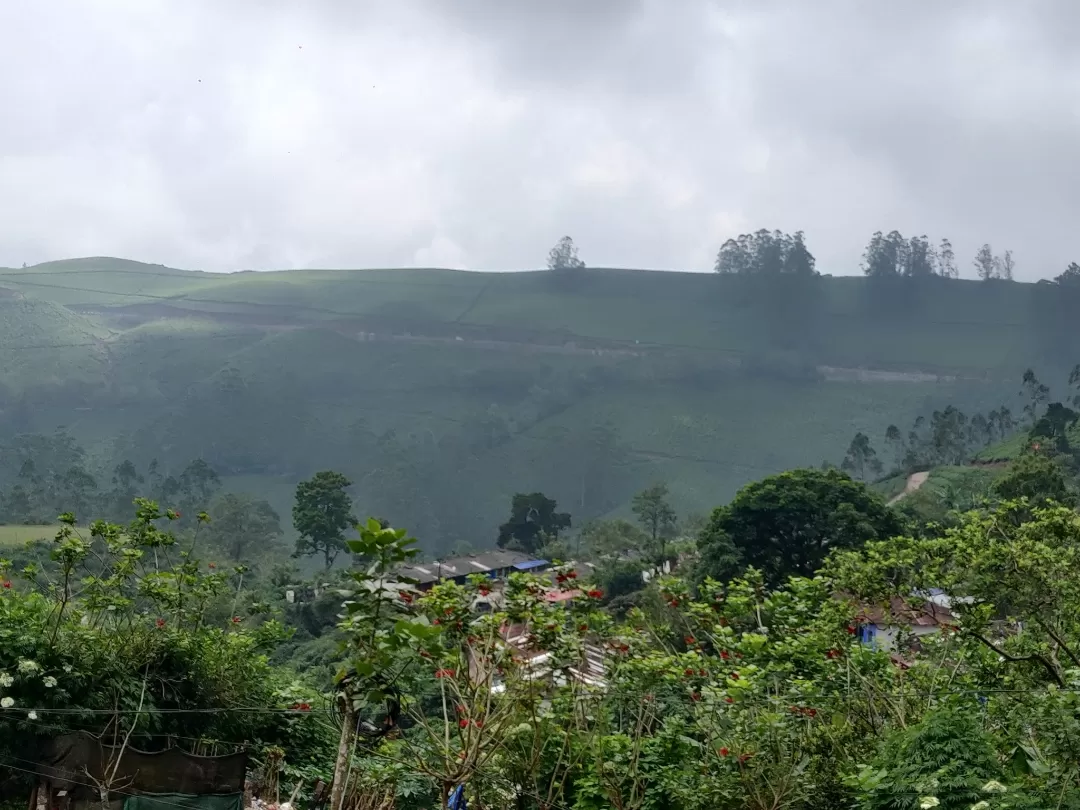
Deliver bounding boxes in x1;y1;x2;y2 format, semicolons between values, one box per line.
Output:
0;258;1072;548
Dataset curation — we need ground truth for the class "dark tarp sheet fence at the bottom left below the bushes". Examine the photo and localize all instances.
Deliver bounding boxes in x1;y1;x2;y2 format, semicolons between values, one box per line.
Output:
37;732;247;796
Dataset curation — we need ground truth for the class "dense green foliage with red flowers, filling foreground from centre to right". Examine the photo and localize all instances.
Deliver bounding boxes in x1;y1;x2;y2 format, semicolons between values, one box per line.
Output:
315;494;1080;810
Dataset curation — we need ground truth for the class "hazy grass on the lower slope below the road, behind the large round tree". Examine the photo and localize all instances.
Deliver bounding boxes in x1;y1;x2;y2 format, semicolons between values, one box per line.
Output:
410;380;1002;529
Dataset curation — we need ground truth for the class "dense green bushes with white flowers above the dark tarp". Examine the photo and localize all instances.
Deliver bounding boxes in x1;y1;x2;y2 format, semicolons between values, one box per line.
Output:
0;500;321;794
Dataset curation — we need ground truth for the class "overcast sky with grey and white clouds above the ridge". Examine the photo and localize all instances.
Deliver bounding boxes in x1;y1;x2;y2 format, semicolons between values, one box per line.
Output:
0;0;1080;279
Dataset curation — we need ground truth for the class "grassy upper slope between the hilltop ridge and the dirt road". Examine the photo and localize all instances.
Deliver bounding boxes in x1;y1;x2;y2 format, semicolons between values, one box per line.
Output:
0;258;1062;375
